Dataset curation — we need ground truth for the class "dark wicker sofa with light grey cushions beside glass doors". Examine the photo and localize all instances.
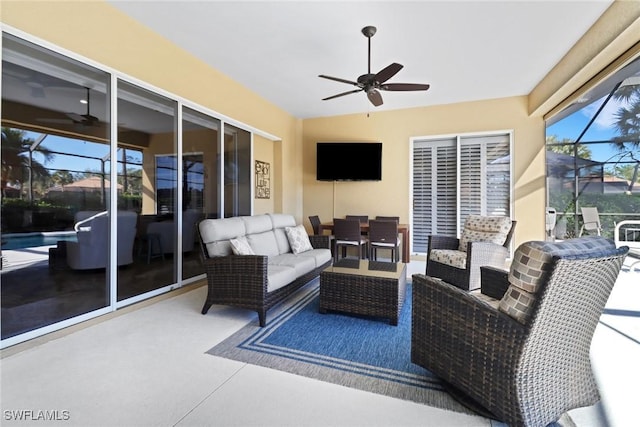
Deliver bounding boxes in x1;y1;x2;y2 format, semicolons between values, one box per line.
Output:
198;214;332;326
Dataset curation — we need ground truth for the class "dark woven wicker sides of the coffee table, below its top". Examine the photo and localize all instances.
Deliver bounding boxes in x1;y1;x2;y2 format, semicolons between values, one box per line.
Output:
320;264;407;325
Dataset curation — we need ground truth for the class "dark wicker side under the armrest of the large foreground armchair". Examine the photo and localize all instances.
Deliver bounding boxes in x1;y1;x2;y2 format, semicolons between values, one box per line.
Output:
411;274;526;412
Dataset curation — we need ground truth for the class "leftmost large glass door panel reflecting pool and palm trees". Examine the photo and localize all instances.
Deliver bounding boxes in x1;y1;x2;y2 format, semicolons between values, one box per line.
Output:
0;33;113;345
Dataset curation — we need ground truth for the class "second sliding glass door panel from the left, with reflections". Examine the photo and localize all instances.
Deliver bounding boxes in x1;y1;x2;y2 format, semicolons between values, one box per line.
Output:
118;81;180;301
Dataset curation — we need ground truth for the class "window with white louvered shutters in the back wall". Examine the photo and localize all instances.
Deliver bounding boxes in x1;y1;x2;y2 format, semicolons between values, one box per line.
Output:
411;132;512;253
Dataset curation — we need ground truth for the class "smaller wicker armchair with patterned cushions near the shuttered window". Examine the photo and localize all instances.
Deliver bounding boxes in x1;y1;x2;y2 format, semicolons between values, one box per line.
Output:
426;215;516;291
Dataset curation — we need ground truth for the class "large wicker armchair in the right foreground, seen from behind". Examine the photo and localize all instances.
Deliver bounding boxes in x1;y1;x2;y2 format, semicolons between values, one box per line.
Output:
411;236;628;426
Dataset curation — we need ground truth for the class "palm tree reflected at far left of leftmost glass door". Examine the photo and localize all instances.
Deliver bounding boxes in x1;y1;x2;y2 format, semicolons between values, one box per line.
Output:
0;127;53;196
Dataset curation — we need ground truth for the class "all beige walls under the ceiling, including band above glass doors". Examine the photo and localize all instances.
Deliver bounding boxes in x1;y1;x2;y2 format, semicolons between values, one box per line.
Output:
1;1;639;244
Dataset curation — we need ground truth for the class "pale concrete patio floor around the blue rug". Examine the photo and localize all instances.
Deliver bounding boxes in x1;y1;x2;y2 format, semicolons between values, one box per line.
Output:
0;261;640;427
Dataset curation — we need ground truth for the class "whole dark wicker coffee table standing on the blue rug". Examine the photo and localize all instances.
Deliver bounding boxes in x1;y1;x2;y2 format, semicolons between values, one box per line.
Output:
320;259;407;325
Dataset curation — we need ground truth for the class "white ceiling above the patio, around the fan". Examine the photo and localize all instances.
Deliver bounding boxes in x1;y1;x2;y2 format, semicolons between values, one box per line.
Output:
110;0;612;118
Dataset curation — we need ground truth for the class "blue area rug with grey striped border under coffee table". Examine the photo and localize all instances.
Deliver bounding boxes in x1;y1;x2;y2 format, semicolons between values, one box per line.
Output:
207;280;472;414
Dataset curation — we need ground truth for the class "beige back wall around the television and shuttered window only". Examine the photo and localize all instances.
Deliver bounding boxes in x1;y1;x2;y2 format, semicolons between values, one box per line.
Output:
303;97;545;249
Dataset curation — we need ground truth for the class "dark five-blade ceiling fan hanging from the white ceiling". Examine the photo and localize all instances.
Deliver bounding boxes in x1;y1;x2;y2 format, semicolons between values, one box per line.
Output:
318;26;429;107
